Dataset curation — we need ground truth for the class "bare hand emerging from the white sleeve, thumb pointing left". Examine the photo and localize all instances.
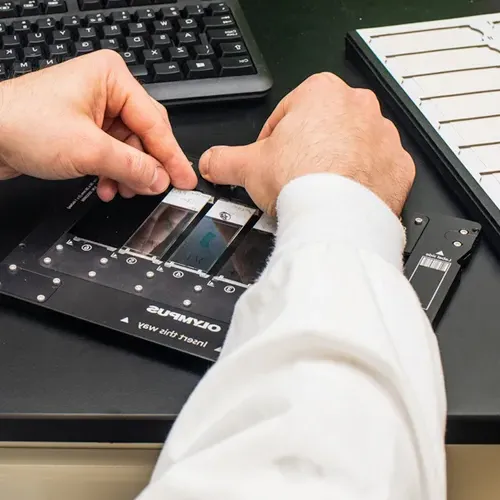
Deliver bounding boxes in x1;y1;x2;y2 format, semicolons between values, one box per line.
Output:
200;73;415;215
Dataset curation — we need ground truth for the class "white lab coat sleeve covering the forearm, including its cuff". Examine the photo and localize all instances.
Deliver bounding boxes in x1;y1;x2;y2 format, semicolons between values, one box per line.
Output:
136;174;446;500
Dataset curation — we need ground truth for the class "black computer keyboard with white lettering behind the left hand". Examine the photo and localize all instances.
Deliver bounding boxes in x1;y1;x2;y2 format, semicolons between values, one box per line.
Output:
0;0;272;103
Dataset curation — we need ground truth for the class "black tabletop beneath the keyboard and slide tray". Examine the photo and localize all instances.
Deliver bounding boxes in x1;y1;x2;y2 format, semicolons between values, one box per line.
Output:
0;0;500;443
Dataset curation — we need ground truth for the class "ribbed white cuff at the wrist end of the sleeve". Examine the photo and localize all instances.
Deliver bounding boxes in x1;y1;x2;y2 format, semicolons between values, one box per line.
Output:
276;173;406;268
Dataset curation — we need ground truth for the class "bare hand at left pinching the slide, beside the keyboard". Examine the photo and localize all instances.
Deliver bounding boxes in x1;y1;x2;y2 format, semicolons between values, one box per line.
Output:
0;50;197;201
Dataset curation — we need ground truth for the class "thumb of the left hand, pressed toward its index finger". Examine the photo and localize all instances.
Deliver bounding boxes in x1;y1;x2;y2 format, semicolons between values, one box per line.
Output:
79;130;170;194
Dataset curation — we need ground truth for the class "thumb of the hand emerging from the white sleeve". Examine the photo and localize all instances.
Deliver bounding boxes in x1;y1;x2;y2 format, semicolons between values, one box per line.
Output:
199;141;264;187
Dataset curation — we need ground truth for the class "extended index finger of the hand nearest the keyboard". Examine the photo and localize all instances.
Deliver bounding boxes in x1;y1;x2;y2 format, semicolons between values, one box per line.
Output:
103;55;196;189
